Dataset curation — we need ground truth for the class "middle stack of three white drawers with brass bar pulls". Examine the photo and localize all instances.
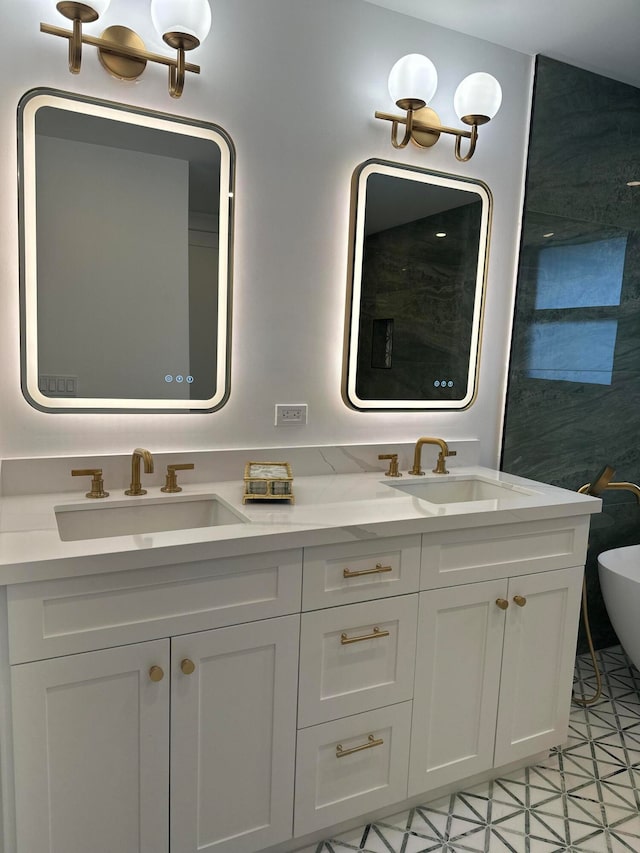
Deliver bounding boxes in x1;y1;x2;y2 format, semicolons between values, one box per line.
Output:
294;536;420;836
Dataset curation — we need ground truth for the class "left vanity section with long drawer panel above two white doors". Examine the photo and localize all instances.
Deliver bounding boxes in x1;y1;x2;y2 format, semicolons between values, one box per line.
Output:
8;552;301;853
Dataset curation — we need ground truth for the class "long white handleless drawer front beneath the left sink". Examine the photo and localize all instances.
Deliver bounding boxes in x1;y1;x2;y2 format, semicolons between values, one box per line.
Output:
7;550;302;663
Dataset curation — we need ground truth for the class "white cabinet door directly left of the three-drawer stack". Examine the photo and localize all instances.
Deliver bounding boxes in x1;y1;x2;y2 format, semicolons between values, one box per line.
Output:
171;615;300;853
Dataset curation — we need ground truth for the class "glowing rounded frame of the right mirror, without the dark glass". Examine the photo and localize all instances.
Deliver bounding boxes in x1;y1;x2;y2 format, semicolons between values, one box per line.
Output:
342;159;493;411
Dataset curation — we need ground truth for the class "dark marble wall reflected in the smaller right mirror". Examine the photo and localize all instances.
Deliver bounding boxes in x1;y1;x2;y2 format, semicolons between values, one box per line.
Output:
357;201;482;400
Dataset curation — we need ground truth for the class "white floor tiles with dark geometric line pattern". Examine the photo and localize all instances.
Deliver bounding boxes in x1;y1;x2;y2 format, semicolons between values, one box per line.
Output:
305;647;640;853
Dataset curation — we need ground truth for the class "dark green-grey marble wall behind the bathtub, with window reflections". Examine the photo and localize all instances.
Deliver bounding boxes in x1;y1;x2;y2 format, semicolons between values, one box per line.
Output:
502;57;640;651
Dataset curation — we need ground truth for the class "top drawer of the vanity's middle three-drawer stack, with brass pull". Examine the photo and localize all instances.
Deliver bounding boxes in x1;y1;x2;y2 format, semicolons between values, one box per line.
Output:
302;535;420;610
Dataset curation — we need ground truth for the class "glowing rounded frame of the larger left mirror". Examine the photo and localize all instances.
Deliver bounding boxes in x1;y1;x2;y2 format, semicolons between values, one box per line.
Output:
18;88;235;413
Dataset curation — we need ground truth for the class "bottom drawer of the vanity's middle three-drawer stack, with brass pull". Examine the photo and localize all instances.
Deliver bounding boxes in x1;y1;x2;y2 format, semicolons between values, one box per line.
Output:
294;702;412;836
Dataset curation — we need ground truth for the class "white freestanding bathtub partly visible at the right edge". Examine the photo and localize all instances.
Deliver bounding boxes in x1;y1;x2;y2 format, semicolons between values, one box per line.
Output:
598;545;640;669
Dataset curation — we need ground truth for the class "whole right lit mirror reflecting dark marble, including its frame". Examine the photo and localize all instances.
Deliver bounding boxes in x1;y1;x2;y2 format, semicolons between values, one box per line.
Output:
344;160;491;410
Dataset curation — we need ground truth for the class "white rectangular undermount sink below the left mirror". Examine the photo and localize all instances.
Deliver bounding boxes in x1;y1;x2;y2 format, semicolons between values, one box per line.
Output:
55;495;247;542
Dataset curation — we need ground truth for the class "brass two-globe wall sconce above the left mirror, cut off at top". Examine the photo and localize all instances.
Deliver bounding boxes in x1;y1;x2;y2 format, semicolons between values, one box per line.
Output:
40;0;211;98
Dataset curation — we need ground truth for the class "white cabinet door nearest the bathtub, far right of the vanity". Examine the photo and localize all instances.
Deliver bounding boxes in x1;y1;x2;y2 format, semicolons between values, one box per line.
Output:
495;567;583;767
